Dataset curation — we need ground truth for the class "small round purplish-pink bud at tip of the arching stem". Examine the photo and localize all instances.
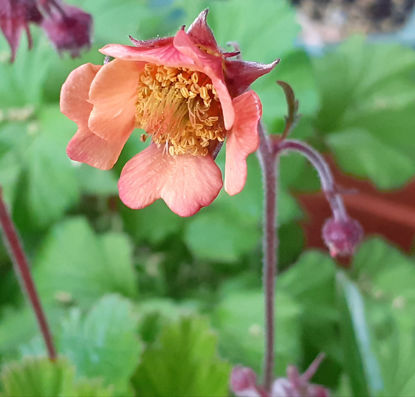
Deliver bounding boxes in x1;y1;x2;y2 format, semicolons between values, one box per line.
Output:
323;217;363;257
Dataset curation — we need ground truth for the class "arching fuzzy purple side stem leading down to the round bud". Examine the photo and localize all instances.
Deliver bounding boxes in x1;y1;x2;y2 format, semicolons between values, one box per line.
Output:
273;139;347;221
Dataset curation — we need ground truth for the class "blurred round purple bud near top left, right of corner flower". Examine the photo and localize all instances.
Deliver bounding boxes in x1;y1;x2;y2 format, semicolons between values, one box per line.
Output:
42;5;92;57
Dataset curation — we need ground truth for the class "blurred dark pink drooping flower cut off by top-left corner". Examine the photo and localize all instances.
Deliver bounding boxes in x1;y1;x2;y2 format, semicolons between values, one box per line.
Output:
0;0;42;62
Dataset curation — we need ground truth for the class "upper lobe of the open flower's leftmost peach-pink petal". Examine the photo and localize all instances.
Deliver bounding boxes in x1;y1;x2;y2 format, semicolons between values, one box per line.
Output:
60;63;101;124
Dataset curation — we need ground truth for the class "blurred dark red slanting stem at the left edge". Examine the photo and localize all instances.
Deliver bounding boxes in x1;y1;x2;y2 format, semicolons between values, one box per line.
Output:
0;187;56;360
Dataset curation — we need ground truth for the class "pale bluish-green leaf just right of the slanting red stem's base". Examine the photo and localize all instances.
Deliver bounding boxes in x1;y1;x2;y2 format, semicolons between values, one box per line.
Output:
59;295;141;395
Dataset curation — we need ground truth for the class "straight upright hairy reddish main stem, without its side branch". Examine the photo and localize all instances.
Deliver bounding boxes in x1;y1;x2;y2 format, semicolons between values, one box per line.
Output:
258;124;278;392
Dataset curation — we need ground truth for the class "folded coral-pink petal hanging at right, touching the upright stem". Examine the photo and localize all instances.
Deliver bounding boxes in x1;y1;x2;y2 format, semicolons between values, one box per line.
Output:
225;91;262;196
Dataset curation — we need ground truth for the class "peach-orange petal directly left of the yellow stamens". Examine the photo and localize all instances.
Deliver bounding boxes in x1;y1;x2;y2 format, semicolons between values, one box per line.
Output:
88;59;144;141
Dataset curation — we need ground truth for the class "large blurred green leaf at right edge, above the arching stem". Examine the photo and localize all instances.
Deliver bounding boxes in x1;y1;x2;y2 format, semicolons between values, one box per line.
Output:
313;38;415;189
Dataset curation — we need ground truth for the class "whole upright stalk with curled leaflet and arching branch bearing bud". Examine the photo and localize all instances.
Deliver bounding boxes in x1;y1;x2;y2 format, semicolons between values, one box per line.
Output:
258;81;363;393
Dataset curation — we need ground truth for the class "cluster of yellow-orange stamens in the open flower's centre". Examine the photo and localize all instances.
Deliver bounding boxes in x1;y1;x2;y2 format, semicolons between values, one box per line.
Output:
135;63;225;156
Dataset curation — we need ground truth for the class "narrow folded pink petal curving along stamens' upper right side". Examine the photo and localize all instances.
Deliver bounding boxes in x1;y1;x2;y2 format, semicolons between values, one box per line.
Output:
174;30;235;130
